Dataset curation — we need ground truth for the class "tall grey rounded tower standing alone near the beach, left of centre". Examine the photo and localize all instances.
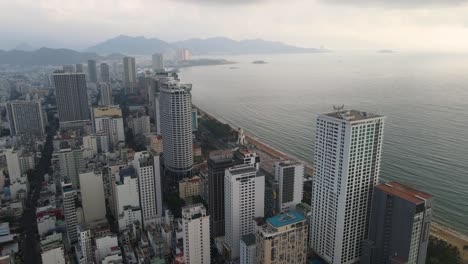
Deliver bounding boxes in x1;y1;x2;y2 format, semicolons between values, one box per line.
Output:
160;79;193;178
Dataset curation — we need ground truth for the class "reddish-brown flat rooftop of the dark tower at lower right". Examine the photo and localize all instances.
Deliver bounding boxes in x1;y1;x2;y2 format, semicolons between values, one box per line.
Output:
375;181;432;204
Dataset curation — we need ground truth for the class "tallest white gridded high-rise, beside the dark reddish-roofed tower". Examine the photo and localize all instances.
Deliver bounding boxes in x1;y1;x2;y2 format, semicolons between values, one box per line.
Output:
310;110;384;264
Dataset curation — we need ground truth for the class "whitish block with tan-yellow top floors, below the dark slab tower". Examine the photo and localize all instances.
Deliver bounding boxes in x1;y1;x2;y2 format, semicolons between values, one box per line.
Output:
91;105;125;150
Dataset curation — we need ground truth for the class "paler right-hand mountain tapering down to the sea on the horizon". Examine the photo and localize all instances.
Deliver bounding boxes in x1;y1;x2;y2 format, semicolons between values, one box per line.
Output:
173;37;321;54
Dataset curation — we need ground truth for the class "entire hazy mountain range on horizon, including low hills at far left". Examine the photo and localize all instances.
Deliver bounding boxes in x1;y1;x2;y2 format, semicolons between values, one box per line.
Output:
0;35;326;65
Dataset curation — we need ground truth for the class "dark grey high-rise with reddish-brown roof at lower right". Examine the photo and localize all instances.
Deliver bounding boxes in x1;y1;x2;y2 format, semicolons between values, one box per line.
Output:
361;182;432;264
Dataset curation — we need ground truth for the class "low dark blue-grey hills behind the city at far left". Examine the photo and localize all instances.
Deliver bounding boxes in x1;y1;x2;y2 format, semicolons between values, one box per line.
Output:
0;48;123;66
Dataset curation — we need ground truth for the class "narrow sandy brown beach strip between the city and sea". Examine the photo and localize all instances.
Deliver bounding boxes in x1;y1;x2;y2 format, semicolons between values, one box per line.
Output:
193;105;468;261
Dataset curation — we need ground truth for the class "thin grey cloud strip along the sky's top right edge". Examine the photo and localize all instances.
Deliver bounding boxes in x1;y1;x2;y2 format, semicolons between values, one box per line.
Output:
319;0;468;8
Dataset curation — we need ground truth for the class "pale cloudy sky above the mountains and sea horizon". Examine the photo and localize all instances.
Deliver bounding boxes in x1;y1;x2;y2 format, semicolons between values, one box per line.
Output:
0;0;468;53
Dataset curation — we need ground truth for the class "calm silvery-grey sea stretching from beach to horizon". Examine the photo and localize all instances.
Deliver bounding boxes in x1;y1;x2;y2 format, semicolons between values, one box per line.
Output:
180;52;468;235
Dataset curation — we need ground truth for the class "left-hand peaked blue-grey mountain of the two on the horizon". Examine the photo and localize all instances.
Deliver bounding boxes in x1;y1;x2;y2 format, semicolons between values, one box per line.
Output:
86;35;174;55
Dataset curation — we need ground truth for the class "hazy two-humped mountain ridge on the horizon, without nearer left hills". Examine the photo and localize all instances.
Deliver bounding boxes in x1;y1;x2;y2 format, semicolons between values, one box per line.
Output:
86;35;323;55
